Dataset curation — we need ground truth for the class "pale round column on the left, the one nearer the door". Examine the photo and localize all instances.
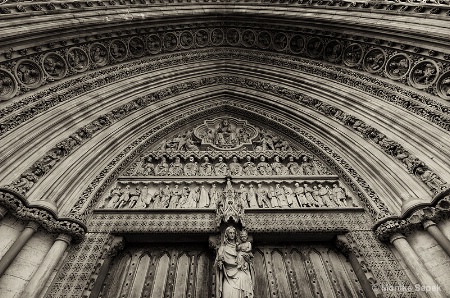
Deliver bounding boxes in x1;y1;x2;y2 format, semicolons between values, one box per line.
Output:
20;234;72;298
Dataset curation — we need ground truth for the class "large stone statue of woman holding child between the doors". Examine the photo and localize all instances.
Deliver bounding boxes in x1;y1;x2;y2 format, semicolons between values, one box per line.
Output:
214;226;254;298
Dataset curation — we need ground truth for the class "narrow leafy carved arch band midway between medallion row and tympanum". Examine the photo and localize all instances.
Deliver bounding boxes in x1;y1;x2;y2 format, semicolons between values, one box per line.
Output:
7;76;449;205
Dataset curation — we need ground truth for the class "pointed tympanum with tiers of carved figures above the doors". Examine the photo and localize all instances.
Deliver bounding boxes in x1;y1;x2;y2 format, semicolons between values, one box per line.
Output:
98;114;360;214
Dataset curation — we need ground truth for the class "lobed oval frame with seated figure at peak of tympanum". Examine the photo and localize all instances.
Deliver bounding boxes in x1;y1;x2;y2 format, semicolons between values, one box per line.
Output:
194;117;258;149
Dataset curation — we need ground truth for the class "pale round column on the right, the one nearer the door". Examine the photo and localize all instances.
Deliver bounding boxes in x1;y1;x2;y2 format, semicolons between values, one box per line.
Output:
389;233;445;298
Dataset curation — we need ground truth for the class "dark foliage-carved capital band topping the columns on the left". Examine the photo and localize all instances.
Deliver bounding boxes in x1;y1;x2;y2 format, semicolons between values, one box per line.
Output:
0;188;86;243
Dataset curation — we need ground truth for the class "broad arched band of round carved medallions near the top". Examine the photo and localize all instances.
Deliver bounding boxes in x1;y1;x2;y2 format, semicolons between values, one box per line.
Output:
0;23;450;118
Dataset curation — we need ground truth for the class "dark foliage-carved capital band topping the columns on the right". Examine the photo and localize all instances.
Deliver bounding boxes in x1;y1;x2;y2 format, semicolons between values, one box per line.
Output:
374;189;450;241
